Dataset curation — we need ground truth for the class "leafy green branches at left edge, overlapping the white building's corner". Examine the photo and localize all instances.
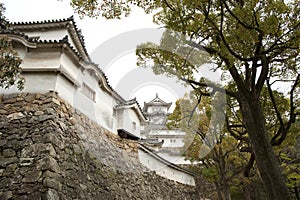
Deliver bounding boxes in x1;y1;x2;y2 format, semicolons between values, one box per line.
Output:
0;3;24;90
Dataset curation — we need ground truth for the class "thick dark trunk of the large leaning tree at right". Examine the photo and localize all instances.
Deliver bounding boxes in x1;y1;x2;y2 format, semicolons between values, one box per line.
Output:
239;93;289;200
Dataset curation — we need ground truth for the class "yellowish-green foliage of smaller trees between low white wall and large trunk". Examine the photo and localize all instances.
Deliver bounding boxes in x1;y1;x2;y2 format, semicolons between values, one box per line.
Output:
169;91;251;197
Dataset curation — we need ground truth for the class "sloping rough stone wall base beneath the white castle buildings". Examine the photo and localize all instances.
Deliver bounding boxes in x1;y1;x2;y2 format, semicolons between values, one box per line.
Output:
0;92;198;200
